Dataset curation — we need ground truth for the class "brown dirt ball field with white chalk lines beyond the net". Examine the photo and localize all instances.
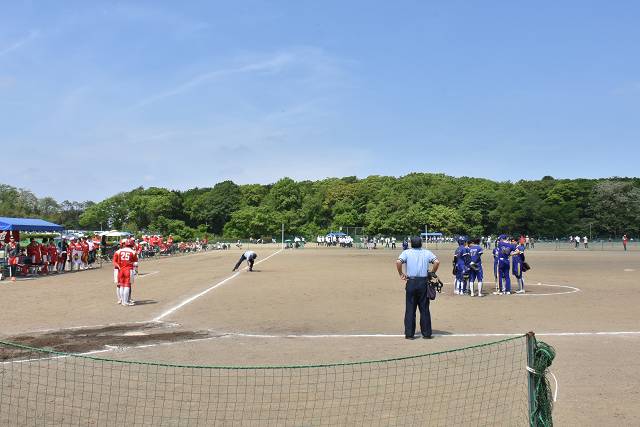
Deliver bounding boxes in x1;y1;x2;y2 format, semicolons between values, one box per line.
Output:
0;245;640;426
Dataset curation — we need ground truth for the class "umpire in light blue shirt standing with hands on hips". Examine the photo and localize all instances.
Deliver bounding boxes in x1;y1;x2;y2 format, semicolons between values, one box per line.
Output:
396;236;440;340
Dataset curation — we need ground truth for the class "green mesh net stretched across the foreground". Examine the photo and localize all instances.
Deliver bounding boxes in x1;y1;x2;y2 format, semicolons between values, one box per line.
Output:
0;336;529;426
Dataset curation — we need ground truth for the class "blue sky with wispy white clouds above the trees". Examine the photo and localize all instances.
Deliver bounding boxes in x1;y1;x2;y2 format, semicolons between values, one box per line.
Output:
0;0;640;202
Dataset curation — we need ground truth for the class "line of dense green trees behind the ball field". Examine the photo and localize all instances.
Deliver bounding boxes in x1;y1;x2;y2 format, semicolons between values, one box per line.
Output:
0;173;640;240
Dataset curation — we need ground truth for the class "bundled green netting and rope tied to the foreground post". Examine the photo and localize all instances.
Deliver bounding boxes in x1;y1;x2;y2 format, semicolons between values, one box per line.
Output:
531;341;556;427
